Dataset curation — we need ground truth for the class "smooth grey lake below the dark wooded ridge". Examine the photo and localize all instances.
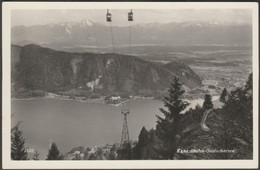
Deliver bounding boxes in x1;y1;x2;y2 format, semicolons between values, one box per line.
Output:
11;98;219;159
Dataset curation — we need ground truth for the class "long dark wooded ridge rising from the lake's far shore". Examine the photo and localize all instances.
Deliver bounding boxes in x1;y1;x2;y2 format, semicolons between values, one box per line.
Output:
11;44;201;96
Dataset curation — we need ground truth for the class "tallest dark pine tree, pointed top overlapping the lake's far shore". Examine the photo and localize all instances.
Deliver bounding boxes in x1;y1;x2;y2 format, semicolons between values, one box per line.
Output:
156;78;189;159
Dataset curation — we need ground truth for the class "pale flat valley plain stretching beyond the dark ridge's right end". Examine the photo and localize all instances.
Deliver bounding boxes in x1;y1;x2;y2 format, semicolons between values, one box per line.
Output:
132;46;252;93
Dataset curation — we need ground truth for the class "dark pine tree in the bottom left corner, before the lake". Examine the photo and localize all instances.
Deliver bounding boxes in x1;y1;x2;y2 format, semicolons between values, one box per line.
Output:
11;122;27;160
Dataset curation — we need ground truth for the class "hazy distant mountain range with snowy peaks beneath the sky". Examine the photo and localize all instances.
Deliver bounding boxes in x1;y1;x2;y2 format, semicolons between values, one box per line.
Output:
11;20;252;52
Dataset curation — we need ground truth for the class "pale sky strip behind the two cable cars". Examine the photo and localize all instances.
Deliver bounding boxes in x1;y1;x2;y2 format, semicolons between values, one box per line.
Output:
11;9;252;26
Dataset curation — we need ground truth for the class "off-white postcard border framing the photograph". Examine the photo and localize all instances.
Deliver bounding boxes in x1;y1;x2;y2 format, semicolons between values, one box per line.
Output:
2;2;259;169
